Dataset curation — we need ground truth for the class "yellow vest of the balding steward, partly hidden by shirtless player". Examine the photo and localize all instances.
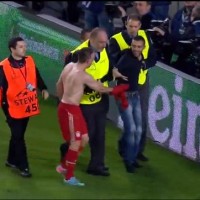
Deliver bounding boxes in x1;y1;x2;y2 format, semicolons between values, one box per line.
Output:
71;40;109;104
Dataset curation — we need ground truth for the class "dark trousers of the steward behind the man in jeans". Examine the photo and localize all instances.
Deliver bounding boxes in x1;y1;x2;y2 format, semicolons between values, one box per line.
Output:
138;74;149;155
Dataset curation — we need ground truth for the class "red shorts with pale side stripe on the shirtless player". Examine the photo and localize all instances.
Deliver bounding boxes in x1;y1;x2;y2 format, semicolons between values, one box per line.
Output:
58;102;88;141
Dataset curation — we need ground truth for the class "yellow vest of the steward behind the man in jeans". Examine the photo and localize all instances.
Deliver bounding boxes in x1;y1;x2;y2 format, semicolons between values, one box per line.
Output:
112;30;149;85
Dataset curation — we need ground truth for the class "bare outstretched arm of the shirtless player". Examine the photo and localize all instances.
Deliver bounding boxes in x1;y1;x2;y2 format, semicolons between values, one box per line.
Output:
83;74;113;93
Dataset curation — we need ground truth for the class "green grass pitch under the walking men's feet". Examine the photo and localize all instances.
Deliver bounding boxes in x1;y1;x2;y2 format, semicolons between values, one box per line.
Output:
0;97;200;199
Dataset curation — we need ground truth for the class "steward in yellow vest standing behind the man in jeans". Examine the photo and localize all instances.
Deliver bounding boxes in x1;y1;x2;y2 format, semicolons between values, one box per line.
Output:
109;15;157;161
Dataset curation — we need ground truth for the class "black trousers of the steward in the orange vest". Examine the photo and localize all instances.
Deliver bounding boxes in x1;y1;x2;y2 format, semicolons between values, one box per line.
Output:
3;106;29;170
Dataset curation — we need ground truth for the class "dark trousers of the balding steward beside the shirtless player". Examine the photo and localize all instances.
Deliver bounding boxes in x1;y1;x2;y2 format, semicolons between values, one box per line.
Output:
81;95;109;170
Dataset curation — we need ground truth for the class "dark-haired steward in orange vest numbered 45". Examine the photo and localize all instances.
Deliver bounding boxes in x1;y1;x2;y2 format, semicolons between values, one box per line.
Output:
0;37;49;177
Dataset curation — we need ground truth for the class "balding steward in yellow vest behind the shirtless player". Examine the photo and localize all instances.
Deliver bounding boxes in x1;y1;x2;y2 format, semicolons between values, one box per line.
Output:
61;28;113;176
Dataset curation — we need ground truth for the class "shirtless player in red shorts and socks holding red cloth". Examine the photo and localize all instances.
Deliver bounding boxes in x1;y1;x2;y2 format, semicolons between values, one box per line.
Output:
56;47;128;186
